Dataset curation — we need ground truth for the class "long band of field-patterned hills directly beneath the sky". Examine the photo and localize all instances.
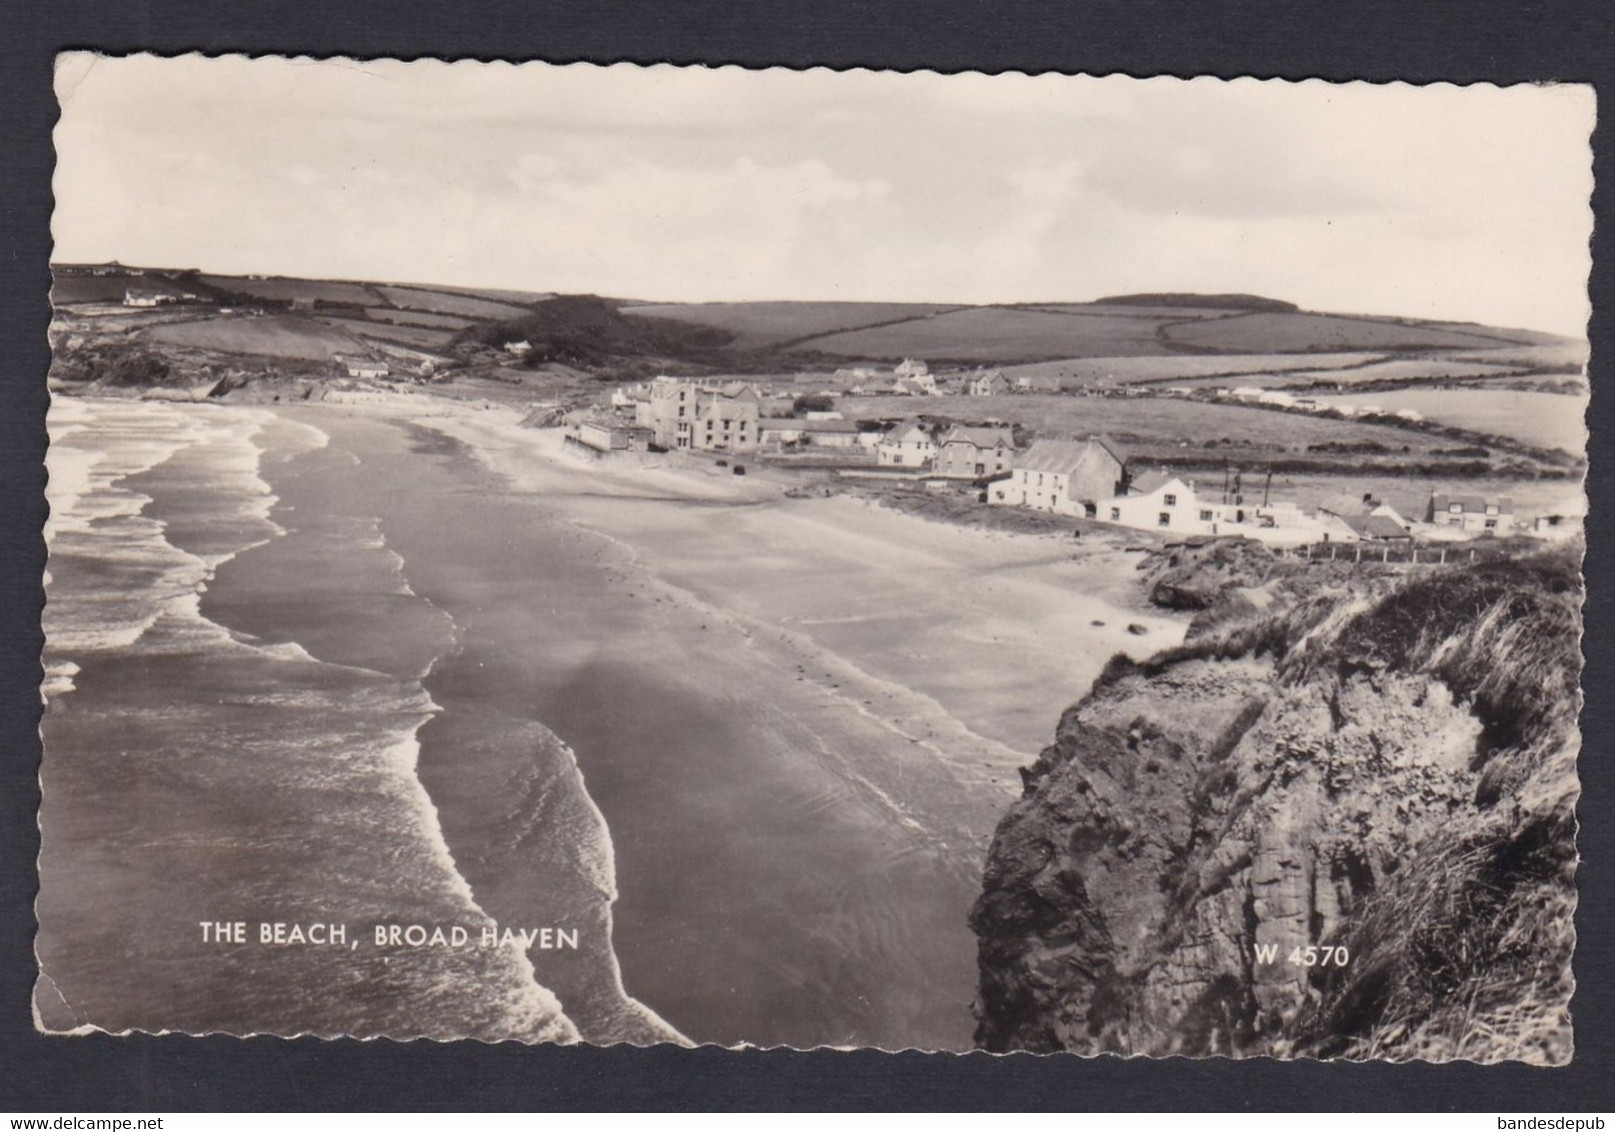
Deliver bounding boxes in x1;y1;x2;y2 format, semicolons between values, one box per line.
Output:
52;265;1586;391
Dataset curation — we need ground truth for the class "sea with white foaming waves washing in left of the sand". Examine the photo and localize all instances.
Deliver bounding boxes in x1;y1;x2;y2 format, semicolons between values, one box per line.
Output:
34;397;668;1043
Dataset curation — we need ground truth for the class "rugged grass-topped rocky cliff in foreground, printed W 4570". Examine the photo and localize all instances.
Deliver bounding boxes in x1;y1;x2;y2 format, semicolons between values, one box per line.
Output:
972;554;1581;1063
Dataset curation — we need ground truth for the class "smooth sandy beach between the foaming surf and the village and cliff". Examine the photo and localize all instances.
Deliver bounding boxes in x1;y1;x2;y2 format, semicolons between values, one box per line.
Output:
287;397;1182;1050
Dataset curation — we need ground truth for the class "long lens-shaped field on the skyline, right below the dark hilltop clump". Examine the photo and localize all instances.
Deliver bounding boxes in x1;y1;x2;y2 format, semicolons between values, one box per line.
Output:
1163;312;1507;354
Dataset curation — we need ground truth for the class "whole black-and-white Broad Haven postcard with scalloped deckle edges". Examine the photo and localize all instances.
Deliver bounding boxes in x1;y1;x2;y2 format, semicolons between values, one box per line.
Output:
34;52;1596;1064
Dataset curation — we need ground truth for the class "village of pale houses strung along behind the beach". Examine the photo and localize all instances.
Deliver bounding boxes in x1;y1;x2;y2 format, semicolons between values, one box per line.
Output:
551;358;1550;559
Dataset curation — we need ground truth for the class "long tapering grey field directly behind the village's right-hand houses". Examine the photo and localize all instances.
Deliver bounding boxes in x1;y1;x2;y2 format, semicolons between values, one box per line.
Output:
859;394;1452;454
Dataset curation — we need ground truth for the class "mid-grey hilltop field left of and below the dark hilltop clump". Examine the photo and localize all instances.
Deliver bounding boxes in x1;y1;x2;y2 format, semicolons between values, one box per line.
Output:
801;307;1171;362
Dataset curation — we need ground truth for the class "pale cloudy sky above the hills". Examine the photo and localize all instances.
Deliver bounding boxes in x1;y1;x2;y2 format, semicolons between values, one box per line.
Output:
52;53;1596;336
